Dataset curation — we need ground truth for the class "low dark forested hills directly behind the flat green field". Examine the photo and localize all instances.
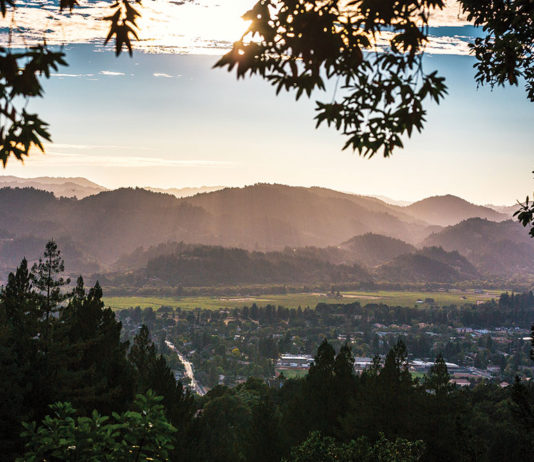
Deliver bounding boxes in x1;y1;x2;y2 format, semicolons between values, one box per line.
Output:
100;243;486;290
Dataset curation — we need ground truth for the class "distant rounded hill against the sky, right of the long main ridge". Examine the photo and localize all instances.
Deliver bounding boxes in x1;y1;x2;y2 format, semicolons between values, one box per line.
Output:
404;195;509;226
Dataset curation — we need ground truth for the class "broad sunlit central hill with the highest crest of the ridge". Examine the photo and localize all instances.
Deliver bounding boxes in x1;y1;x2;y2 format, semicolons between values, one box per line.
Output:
184;184;431;250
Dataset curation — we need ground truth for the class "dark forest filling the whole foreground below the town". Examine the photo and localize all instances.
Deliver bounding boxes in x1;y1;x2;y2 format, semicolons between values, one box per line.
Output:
0;242;534;462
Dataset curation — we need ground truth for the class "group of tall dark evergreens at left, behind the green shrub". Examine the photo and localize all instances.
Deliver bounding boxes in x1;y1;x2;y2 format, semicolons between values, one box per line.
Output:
0;242;193;461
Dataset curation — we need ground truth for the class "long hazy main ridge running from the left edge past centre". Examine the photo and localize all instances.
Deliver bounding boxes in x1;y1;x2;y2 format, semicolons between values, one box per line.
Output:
0;185;435;265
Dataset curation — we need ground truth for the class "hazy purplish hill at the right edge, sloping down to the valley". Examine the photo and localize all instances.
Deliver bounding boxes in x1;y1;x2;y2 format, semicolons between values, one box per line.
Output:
424;218;534;276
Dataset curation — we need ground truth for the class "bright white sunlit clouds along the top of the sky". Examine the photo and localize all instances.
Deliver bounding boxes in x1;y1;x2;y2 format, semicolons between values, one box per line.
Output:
0;0;478;55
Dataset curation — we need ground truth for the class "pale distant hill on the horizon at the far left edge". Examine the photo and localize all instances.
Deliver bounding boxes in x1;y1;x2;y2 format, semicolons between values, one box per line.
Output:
0;175;106;199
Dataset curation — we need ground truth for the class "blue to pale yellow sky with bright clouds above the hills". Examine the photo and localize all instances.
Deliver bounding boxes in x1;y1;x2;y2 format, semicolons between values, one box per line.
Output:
0;0;534;204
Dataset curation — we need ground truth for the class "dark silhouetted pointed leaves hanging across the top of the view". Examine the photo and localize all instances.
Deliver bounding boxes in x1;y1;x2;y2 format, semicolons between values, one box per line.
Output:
0;0;534;166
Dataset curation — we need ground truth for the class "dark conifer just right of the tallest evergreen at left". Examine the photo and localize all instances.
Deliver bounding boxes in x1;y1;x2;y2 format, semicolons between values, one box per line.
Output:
49;277;136;414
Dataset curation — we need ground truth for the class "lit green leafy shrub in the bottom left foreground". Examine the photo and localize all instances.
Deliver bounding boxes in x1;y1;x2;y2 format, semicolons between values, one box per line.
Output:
17;391;176;462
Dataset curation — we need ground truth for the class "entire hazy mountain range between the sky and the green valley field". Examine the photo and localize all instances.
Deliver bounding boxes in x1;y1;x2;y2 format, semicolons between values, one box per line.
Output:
0;177;534;284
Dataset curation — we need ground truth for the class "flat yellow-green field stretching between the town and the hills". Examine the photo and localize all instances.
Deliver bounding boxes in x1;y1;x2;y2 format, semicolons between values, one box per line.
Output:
104;290;502;310
